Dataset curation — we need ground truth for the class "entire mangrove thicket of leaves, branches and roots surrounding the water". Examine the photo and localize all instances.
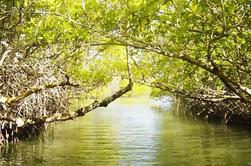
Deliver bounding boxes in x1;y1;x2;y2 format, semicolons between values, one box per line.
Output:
0;0;251;143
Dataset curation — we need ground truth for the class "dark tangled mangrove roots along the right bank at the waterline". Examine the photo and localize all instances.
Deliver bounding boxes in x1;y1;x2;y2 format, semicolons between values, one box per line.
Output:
175;98;251;129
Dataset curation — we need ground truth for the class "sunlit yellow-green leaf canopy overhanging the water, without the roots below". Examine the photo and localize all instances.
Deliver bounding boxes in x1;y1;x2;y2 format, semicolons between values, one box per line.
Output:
9;0;251;98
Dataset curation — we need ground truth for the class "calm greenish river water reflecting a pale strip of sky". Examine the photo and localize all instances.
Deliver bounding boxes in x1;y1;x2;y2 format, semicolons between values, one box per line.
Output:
0;98;251;166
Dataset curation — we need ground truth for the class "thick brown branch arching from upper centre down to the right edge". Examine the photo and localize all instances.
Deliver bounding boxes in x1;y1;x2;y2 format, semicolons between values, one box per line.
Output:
102;30;251;103
